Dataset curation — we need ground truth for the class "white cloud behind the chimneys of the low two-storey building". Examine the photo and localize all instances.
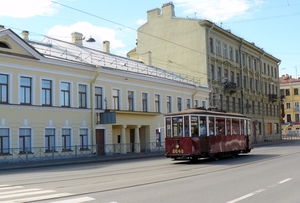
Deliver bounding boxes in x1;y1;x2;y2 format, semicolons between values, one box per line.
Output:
46;22;125;50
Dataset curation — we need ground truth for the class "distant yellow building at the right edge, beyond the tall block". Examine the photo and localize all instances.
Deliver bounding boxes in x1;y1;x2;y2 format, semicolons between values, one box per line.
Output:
280;74;300;135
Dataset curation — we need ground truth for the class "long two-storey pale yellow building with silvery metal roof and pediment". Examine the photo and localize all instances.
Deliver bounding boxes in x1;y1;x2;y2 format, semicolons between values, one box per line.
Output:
0;26;210;156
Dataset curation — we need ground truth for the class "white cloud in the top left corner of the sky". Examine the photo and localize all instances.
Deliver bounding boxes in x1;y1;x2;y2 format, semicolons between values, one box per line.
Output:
0;0;57;18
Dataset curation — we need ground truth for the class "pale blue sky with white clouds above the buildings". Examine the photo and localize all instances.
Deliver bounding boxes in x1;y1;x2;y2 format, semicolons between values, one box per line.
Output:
0;0;300;77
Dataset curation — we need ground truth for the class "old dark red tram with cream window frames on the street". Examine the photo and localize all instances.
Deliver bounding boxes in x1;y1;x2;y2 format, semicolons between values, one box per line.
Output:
165;108;252;160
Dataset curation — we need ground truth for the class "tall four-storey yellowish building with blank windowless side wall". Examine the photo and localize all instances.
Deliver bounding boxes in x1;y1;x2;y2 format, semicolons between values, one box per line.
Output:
127;2;281;141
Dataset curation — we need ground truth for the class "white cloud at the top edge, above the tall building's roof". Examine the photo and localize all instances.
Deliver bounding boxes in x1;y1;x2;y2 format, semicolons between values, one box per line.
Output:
173;0;264;22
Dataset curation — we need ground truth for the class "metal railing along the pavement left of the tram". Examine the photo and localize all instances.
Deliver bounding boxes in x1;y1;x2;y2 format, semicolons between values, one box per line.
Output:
0;142;165;169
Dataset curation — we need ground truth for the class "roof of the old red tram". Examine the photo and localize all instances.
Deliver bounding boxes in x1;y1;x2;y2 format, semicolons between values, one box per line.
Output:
165;108;248;118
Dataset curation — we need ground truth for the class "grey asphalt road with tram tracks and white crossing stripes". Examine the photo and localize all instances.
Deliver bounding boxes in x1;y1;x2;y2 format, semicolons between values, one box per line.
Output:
0;141;300;203
